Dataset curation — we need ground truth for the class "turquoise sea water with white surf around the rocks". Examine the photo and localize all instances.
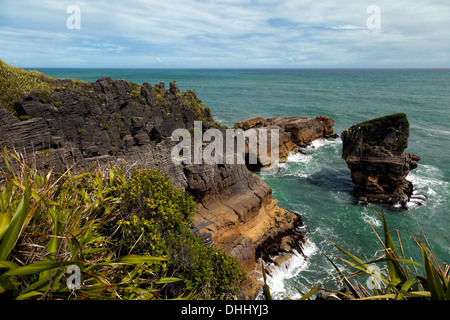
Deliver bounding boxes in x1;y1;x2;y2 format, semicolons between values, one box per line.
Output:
40;69;450;299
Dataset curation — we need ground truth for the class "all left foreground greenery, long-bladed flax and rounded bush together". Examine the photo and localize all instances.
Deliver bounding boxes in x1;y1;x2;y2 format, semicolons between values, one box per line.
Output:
0;150;243;300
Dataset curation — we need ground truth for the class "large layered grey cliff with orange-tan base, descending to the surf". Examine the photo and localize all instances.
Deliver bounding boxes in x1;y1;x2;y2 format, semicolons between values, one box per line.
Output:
0;78;302;298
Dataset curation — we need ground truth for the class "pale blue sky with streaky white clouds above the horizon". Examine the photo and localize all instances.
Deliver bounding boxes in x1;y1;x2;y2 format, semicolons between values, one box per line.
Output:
0;0;450;68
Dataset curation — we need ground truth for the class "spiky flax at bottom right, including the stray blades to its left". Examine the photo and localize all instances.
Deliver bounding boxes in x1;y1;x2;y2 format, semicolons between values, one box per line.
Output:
262;207;450;300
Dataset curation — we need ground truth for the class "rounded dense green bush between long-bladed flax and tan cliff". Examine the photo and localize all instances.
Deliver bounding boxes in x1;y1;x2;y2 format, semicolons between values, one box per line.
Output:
118;170;244;299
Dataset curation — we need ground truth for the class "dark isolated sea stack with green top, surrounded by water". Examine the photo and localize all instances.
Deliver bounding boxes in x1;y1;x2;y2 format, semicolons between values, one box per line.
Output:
341;113;420;209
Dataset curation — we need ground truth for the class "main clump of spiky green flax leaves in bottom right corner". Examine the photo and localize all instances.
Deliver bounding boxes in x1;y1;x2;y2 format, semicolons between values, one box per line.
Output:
320;205;450;300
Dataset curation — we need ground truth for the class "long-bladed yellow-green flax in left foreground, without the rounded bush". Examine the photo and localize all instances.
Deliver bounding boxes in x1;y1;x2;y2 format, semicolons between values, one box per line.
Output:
0;149;179;300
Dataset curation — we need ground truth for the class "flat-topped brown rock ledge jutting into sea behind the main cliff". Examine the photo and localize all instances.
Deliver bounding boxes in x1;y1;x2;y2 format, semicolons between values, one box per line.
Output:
234;116;337;170
